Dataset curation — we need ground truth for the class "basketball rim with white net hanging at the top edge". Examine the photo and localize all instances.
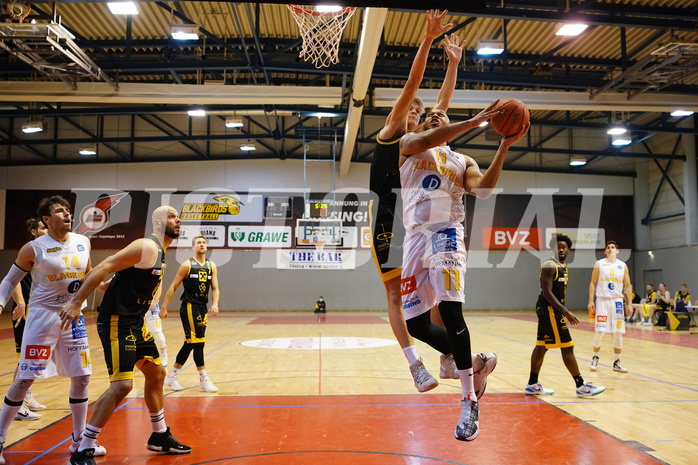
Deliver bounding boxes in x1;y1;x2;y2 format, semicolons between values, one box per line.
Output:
286;4;356;69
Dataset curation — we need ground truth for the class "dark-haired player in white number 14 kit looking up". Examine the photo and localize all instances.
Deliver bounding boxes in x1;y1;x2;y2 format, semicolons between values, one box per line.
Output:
0;196;106;464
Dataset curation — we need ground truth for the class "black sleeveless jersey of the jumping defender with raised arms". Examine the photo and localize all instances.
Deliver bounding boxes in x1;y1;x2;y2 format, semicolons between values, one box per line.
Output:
369;133;406;210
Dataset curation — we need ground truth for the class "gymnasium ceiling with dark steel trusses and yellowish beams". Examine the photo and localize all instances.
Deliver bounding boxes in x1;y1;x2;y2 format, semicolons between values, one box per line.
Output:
0;0;698;175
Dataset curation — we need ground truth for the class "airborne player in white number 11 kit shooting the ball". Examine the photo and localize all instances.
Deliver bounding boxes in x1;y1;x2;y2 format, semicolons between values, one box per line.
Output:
400;100;528;441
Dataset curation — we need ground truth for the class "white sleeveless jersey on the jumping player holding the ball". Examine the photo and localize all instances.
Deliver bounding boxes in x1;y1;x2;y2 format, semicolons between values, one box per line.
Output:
400;146;466;234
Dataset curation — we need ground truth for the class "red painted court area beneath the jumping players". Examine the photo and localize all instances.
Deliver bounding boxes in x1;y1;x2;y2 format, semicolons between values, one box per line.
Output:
5;394;660;465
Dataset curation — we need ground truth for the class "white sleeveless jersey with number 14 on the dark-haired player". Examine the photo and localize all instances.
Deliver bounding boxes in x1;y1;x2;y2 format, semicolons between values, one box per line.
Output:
29;233;90;311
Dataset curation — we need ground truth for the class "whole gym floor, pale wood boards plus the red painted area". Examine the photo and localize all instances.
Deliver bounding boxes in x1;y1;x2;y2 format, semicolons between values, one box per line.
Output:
0;312;698;465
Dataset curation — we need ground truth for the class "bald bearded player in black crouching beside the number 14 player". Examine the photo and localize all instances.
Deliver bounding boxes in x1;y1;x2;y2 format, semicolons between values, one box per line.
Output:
61;206;191;465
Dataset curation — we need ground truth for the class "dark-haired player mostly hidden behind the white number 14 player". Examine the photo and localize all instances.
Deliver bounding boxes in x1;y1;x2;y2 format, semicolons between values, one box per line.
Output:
12;217;48;421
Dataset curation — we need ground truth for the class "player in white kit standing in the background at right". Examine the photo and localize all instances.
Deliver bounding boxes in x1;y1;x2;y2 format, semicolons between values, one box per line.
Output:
588;241;633;373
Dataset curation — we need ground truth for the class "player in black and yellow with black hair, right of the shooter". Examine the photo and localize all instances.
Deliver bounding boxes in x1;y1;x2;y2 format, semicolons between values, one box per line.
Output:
525;234;606;397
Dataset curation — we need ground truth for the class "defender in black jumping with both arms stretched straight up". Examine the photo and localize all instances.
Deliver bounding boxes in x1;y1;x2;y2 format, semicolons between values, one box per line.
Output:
370;10;497;395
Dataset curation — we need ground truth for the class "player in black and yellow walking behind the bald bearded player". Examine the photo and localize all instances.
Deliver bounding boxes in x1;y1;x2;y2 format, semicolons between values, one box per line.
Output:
160;236;220;392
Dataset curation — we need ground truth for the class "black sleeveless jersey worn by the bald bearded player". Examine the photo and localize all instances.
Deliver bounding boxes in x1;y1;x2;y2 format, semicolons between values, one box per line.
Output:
99;234;165;318
